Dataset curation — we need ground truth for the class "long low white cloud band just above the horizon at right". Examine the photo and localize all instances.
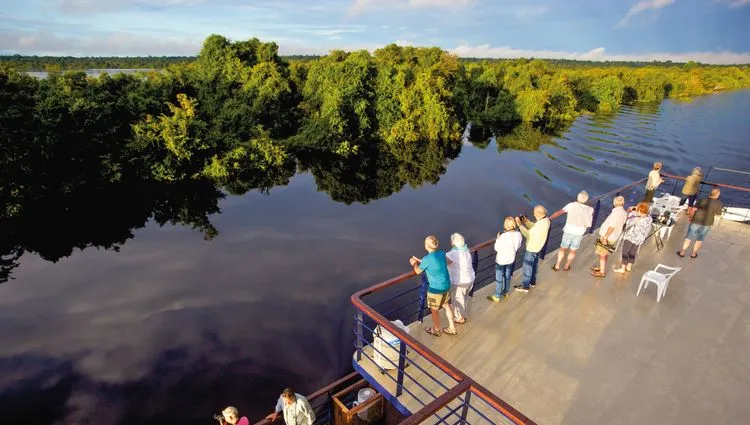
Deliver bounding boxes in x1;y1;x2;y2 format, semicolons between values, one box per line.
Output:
449;44;750;64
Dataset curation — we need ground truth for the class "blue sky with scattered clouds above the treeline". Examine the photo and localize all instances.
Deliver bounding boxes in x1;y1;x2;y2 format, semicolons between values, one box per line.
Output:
0;0;750;63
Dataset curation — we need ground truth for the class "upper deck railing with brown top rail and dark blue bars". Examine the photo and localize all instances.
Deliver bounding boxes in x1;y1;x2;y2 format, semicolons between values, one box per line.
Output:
351;173;750;425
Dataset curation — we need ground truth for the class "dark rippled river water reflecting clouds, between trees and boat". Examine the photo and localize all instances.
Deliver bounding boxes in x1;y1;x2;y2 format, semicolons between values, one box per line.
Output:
0;91;750;425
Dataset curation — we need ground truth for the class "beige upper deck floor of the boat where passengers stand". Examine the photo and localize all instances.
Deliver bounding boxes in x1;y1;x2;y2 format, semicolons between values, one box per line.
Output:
361;220;750;425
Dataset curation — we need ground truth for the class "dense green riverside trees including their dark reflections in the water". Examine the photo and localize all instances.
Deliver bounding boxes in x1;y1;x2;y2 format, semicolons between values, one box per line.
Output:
0;35;750;282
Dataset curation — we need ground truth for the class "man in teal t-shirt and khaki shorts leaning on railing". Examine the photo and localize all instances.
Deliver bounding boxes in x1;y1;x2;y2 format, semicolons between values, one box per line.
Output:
409;236;456;336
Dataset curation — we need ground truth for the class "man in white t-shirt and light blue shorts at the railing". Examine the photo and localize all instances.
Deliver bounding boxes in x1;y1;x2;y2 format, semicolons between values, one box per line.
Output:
549;191;594;271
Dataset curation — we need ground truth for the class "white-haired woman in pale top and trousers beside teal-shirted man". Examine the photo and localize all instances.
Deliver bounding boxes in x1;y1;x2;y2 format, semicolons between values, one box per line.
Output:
445;233;474;324
